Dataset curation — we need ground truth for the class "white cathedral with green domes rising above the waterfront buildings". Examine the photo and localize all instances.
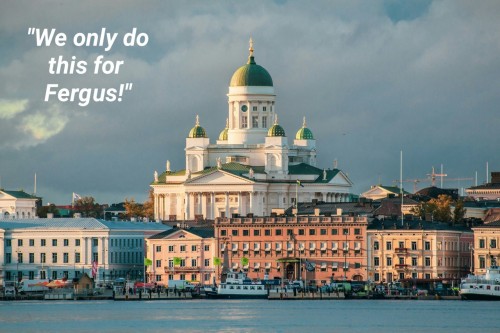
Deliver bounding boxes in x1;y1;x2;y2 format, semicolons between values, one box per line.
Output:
151;40;352;221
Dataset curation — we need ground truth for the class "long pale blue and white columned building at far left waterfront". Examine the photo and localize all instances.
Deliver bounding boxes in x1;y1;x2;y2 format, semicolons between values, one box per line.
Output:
0;218;170;283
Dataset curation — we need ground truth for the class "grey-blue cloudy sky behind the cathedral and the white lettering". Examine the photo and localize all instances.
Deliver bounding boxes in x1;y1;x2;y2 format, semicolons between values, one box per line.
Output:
0;0;500;205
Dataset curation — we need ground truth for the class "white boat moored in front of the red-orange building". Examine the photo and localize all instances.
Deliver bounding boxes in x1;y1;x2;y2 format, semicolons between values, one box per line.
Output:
205;271;271;299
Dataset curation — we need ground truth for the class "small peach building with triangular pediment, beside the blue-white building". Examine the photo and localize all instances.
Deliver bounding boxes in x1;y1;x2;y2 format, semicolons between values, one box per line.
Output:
146;227;217;286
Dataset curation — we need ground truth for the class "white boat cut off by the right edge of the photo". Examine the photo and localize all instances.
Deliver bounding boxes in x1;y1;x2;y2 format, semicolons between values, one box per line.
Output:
460;266;500;301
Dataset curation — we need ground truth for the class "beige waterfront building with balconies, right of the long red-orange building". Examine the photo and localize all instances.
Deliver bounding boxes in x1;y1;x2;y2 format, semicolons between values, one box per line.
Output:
367;219;473;283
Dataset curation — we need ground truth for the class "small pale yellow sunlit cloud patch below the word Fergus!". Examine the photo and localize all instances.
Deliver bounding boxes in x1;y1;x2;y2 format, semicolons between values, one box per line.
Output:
20;104;69;145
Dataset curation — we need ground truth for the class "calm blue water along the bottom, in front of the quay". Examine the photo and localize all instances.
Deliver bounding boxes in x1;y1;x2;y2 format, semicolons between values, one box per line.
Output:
0;300;500;333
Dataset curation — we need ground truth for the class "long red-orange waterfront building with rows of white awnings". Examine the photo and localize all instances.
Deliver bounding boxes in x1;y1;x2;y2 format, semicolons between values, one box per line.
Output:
215;215;368;285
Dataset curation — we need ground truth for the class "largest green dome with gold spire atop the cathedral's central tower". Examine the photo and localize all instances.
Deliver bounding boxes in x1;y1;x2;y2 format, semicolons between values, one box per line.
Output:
229;39;273;87
